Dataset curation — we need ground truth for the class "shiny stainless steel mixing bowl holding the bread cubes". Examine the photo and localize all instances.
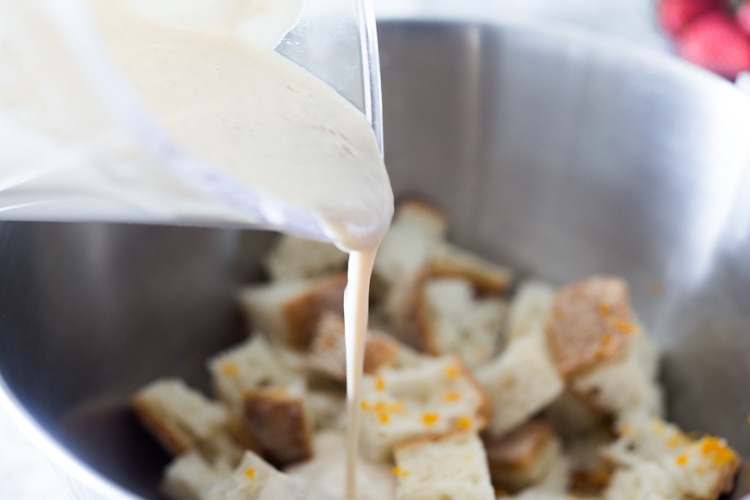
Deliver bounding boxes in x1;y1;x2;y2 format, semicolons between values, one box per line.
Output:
0;22;750;498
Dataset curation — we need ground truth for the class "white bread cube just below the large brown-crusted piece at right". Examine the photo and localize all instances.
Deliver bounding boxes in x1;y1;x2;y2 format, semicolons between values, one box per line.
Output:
568;333;663;419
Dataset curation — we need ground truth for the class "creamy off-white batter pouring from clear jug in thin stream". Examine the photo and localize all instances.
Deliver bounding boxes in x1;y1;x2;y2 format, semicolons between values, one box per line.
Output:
90;0;393;499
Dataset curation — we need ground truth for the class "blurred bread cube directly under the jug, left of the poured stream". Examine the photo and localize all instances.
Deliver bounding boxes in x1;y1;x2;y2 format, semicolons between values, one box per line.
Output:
264;235;348;281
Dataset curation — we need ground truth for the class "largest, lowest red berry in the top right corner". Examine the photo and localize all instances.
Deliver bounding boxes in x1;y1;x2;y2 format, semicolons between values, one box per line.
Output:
676;12;750;79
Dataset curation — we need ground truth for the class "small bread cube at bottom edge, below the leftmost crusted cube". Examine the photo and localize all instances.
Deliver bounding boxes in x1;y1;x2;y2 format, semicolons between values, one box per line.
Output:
160;450;231;500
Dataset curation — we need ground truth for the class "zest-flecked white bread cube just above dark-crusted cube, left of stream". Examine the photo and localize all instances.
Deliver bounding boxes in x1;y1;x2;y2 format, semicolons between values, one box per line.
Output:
208;334;301;415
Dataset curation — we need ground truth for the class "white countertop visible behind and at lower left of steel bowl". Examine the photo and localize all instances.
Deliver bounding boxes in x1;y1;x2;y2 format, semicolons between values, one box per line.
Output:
0;0;666;500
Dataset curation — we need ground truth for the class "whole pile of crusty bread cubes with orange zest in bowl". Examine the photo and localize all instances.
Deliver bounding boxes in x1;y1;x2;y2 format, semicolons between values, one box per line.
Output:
133;200;740;500
